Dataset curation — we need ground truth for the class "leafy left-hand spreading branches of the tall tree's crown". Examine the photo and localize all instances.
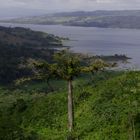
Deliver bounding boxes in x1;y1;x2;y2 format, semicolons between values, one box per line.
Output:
16;59;56;91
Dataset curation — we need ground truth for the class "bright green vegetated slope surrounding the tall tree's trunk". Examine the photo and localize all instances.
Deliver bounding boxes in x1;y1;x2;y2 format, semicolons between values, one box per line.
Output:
0;72;140;140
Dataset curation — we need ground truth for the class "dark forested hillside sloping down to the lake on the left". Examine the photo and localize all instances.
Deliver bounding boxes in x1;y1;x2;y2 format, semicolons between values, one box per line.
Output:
0;27;62;83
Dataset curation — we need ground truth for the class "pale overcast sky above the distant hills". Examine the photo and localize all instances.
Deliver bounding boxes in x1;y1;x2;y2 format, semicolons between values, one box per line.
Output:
0;0;140;18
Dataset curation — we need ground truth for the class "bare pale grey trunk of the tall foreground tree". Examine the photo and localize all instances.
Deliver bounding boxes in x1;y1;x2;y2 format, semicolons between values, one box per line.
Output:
68;80;74;133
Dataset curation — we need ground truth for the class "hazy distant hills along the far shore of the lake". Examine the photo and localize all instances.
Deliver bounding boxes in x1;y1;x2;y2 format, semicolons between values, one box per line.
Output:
1;10;140;29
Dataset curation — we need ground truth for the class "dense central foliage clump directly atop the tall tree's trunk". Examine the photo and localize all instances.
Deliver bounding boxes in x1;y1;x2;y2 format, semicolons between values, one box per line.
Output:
54;50;81;81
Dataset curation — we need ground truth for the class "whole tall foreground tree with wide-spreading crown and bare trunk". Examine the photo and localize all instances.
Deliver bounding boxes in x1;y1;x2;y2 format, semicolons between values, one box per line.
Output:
19;50;110;139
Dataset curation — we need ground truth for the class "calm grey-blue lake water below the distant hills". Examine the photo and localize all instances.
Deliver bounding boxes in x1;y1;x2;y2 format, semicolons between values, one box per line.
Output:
0;23;140;69
